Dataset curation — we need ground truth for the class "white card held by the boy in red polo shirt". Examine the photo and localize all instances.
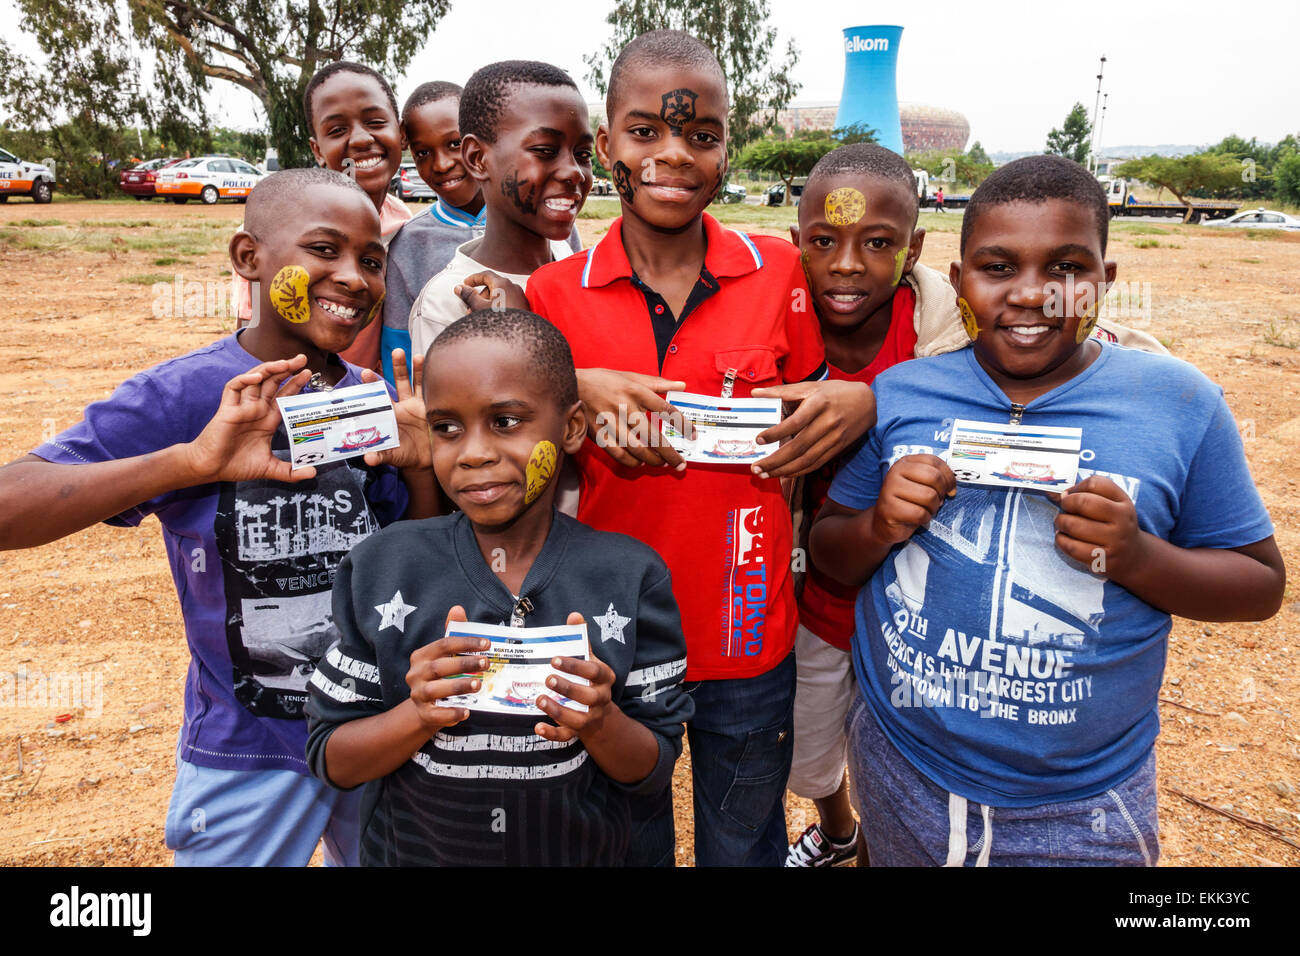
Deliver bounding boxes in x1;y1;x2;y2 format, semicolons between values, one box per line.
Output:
663;392;781;464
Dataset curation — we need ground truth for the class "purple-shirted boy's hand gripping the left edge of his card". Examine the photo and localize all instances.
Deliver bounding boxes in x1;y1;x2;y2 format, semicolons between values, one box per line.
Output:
186;355;316;484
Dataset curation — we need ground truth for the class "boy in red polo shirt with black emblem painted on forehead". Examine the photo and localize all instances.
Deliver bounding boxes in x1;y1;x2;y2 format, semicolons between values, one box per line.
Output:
528;30;875;866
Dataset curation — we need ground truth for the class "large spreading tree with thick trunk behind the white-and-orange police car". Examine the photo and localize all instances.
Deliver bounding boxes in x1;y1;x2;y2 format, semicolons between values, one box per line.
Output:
126;0;450;168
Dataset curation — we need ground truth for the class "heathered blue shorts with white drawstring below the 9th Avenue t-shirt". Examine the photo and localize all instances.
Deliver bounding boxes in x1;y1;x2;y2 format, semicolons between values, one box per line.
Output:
845;692;1160;866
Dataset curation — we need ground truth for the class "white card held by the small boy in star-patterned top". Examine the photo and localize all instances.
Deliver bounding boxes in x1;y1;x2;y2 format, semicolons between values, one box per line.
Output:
439;620;592;717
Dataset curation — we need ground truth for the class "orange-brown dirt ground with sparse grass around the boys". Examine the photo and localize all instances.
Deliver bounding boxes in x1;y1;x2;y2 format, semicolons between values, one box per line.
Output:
0;202;1300;866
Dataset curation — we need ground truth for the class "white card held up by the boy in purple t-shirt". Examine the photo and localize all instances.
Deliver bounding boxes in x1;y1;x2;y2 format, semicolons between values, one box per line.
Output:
276;382;398;468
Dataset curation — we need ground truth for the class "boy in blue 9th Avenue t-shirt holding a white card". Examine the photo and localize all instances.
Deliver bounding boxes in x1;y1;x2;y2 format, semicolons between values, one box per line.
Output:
811;156;1286;866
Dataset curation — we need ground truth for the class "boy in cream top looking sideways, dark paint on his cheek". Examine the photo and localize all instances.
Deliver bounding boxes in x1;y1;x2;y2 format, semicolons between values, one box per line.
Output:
410;60;593;354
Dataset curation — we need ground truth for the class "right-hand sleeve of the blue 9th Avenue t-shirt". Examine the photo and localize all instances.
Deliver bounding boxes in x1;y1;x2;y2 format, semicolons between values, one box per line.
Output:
1169;389;1273;549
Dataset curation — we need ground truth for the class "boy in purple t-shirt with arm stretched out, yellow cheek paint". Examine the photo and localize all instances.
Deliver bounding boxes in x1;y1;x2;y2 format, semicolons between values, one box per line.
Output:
0;169;436;865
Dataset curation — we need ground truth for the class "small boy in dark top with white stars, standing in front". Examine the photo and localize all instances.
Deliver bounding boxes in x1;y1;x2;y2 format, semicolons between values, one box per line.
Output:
307;310;692;866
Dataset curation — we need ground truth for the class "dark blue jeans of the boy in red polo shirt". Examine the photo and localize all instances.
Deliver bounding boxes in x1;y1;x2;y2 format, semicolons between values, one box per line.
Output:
628;654;796;866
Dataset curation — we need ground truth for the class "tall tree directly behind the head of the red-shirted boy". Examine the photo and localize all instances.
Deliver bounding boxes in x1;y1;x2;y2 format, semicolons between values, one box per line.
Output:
582;0;800;156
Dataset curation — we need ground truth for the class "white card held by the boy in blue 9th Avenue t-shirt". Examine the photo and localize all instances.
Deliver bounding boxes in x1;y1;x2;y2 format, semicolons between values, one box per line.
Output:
948;419;1083;492
